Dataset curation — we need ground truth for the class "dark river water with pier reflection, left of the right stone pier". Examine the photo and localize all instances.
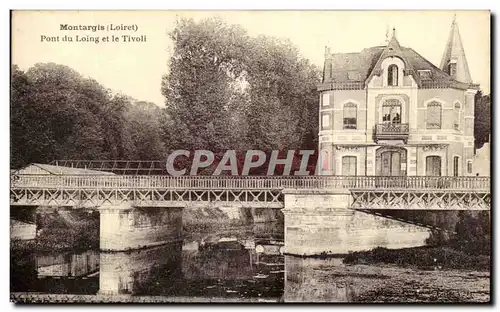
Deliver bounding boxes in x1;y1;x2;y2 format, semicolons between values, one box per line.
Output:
11;226;284;300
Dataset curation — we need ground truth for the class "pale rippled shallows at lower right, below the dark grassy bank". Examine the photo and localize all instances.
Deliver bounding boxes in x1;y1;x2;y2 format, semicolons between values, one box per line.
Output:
285;257;490;303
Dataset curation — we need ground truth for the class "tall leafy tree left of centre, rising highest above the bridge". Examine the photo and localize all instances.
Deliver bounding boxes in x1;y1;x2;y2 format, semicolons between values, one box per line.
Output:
162;19;249;152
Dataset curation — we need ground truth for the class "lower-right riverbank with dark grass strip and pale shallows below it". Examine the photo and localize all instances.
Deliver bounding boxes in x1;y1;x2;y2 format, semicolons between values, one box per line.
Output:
285;246;491;303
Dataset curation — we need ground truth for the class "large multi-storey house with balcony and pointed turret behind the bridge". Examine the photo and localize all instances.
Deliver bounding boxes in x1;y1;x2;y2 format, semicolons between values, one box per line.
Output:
318;20;478;176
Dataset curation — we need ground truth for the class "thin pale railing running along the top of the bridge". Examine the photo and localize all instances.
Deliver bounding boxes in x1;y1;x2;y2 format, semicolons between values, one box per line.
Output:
11;174;490;191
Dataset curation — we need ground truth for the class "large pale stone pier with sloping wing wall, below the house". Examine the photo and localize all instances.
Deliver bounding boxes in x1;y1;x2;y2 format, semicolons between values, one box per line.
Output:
283;189;430;255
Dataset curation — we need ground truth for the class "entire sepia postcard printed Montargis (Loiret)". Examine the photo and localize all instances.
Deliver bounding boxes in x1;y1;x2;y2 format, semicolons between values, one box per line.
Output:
10;11;491;303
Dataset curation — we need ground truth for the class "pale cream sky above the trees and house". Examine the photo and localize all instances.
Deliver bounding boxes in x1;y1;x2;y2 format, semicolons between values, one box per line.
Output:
12;11;490;106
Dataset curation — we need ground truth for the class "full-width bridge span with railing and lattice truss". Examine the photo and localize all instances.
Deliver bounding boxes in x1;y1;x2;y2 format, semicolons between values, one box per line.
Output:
10;174;490;209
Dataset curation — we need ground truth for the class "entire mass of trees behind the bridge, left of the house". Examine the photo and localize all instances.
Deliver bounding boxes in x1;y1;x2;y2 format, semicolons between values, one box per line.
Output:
11;19;320;172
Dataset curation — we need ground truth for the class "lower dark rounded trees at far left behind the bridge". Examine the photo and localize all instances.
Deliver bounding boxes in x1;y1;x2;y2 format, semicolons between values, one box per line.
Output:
11;63;162;168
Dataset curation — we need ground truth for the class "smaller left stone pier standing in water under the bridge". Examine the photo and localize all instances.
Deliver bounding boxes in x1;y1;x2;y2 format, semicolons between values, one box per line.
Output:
99;203;182;251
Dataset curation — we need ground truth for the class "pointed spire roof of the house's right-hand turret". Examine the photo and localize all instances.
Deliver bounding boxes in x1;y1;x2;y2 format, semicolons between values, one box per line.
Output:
439;18;472;83
